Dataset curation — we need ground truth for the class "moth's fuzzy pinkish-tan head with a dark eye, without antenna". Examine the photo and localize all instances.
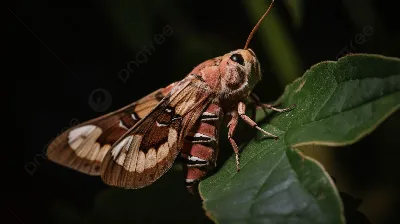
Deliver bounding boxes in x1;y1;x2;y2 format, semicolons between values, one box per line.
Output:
219;49;261;95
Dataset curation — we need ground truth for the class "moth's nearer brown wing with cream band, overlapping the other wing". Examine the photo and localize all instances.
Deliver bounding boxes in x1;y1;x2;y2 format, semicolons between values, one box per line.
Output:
101;79;213;189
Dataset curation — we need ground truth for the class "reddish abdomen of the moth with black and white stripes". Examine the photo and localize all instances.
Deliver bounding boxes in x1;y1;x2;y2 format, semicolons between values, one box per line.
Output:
181;104;223;192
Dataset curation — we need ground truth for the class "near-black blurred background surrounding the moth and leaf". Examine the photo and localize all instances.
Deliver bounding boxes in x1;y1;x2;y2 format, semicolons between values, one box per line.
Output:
5;0;400;224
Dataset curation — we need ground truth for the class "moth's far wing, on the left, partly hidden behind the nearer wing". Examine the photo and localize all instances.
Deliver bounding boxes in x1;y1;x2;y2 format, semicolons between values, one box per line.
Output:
47;84;174;175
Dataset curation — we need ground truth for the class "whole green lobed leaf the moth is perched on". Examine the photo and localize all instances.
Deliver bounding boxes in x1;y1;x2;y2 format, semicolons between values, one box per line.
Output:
200;54;400;223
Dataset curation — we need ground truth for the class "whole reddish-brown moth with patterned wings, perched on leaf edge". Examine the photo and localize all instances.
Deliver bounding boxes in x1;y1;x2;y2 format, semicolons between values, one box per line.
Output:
47;1;294;193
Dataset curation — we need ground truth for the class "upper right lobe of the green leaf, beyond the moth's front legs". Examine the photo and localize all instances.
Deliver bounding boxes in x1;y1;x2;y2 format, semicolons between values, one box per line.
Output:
271;54;400;146
